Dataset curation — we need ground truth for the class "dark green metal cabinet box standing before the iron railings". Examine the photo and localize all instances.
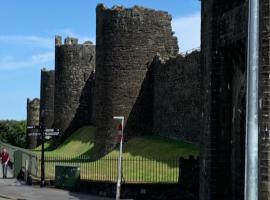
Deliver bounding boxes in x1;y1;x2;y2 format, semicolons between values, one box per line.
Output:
55;165;80;191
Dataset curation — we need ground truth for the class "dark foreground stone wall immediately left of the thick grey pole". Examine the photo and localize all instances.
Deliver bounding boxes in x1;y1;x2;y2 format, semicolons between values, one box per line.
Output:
200;0;248;200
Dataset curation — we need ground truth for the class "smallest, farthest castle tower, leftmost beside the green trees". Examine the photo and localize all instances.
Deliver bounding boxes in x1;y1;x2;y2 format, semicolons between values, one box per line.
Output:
26;98;40;149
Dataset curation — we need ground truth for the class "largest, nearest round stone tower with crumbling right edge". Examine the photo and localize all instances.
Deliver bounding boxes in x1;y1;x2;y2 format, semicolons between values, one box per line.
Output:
95;4;178;151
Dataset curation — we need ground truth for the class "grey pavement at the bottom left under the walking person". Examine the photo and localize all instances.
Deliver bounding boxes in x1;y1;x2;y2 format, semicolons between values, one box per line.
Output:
0;178;113;200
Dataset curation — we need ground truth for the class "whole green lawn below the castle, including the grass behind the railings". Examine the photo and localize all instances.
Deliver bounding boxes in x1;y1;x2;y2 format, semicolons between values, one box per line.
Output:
35;127;199;182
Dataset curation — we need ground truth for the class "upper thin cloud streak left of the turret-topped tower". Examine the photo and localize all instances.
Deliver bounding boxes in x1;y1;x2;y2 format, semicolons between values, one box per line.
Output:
0;35;54;49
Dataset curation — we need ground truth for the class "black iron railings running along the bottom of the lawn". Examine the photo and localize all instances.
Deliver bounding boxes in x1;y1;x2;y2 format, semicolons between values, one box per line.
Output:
38;156;180;183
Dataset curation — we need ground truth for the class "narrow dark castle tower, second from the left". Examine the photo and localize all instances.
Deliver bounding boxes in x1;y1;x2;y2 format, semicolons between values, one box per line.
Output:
40;69;54;128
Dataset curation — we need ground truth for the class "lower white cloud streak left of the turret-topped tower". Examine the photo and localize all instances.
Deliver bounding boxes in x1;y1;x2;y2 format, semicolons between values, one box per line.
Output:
0;52;54;70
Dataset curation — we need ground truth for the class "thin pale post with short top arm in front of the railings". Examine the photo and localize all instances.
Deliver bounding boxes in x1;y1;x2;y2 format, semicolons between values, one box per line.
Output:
113;116;124;200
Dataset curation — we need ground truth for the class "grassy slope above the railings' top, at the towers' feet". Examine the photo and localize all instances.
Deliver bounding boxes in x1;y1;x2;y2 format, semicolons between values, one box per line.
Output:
36;126;199;159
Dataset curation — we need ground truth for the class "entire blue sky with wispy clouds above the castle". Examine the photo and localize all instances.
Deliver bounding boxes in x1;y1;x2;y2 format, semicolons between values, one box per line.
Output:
0;0;200;120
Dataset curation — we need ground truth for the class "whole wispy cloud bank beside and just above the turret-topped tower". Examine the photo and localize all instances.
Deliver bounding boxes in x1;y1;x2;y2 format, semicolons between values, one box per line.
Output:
0;28;95;70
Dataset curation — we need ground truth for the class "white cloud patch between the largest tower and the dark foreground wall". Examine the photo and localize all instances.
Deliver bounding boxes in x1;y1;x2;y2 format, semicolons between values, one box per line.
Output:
172;13;201;52
